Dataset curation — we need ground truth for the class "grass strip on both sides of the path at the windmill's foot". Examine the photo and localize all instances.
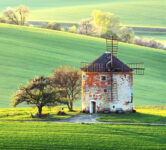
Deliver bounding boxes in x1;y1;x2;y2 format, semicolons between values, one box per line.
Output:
0;106;166;124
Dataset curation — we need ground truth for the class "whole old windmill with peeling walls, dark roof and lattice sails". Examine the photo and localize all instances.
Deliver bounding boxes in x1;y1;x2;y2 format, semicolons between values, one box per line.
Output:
81;37;144;113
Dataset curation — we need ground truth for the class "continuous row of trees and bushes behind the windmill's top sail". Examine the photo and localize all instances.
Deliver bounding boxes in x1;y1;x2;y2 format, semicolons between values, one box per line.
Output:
41;10;166;50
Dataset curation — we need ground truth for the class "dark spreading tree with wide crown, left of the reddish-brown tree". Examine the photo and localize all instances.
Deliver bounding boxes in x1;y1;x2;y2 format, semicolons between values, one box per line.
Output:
11;76;65;117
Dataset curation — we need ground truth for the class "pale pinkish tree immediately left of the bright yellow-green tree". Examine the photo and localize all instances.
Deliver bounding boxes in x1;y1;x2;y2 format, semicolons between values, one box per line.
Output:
79;18;94;35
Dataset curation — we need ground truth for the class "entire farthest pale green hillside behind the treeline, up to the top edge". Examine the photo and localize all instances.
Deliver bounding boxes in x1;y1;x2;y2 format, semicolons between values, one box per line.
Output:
0;0;166;27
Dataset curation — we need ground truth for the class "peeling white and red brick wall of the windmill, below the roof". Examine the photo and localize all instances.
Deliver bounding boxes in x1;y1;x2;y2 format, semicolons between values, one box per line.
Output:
82;72;133;112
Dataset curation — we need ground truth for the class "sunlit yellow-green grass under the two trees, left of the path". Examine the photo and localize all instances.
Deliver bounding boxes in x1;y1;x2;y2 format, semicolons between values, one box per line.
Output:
0;107;80;121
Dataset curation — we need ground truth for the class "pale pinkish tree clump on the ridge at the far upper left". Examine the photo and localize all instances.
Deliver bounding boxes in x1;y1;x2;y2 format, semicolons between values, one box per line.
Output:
3;5;29;25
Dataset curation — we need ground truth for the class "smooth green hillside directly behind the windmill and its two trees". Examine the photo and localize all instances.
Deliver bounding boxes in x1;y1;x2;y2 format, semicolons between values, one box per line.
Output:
0;24;166;108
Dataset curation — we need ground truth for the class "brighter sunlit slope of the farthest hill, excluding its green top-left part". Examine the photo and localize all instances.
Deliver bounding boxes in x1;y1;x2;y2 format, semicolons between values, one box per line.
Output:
30;0;166;27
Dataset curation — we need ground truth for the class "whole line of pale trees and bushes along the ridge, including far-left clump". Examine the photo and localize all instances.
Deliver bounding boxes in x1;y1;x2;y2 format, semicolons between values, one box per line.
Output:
0;5;166;50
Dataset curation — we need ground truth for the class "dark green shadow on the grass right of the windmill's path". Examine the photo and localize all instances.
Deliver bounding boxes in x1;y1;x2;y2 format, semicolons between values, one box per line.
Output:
97;112;166;123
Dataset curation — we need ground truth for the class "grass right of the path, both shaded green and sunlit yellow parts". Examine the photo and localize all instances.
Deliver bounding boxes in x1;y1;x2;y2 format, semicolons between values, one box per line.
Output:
97;106;166;123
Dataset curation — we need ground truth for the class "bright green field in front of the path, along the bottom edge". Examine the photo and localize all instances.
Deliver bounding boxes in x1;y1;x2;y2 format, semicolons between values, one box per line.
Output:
0;122;166;150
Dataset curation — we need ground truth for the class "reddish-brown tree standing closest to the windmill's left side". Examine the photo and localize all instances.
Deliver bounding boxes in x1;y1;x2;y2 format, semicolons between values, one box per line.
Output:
52;66;81;111
